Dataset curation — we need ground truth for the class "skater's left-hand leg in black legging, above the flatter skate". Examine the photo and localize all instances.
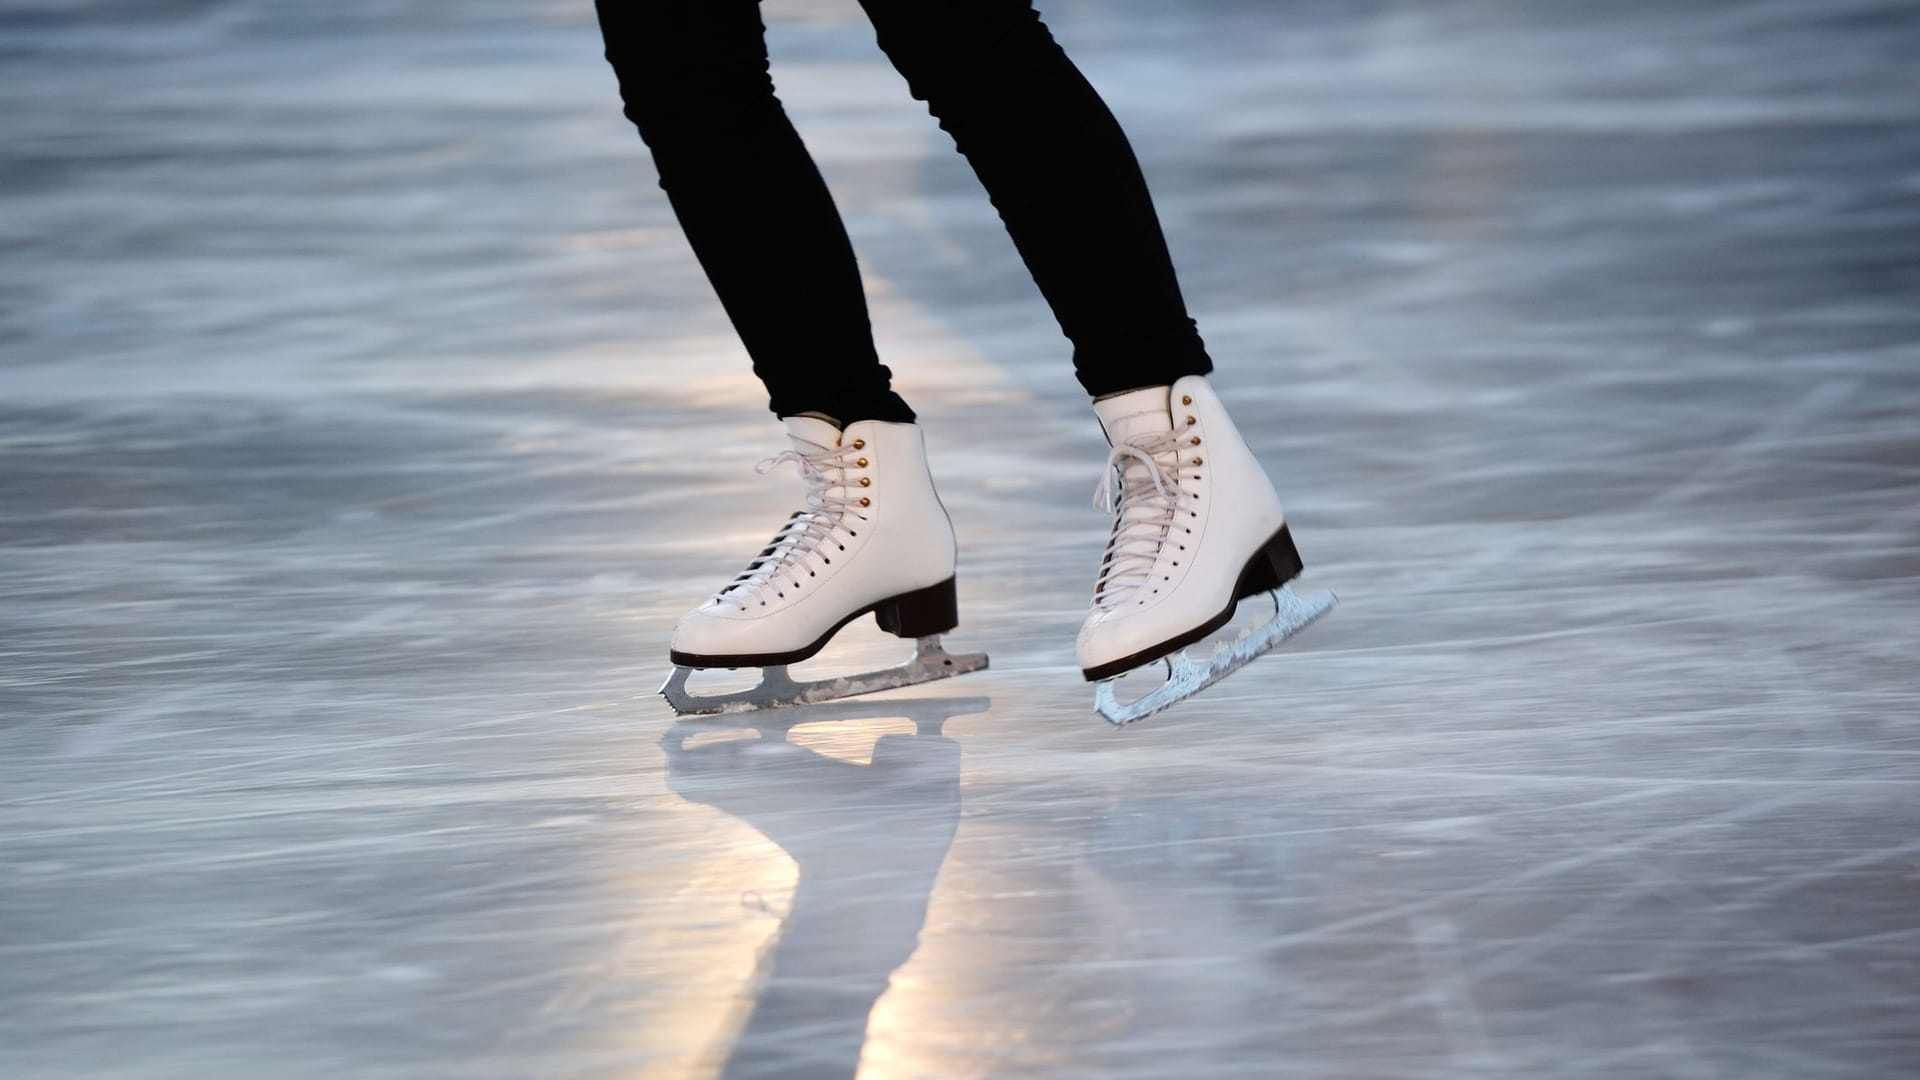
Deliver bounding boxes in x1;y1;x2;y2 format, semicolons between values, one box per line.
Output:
595;0;914;425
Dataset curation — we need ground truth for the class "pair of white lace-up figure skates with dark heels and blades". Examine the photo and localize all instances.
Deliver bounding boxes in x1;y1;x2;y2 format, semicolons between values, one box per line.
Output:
660;375;1334;724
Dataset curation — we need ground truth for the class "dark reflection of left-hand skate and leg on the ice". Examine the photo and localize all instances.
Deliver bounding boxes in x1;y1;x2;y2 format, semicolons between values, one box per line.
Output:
660;698;991;1078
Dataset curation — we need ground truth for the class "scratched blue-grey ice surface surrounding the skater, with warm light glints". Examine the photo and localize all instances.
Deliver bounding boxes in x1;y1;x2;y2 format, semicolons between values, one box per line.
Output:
0;0;1920;1080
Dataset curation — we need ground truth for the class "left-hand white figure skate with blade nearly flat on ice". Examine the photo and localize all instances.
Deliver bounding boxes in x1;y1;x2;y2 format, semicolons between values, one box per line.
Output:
660;417;987;715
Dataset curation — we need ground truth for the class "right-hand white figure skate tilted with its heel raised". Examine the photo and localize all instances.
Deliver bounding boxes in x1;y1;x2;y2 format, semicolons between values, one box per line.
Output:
1077;375;1334;724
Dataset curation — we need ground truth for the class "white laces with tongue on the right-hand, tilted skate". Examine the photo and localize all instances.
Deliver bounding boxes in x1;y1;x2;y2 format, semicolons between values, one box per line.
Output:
1092;432;1183;607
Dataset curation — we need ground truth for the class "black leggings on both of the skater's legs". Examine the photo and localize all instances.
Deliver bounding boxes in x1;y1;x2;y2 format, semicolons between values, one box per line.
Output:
595;0;1212;423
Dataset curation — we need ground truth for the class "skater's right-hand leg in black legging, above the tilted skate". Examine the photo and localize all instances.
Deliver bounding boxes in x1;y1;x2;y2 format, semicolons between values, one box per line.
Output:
860;0;1212;396
